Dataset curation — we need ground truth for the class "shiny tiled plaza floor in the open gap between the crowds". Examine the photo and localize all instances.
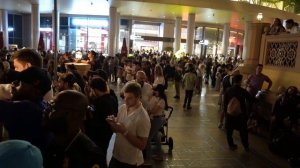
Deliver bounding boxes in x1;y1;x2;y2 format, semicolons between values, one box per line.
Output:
108;84;289;168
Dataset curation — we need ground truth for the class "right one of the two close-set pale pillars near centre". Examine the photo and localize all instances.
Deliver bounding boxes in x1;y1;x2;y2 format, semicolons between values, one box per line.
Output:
186;13;195;55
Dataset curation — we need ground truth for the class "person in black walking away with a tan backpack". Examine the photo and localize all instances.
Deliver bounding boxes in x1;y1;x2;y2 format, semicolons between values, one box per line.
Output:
224;75;253;151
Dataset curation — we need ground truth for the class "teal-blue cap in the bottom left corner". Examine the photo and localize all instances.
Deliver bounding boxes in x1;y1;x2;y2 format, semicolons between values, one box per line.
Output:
0;140;43;168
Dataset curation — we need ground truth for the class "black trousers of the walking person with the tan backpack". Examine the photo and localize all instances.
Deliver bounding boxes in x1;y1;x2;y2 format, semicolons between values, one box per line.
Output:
225;115;249;148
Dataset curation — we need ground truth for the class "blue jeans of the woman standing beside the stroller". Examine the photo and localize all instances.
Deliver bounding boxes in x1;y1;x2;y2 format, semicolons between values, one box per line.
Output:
145;117;165;160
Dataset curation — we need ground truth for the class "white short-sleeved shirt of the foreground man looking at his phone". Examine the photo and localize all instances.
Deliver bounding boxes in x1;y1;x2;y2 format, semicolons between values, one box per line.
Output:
113;104;151;166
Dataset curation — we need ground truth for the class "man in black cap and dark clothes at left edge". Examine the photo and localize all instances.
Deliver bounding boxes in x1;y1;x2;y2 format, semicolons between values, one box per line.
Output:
0;67;51;150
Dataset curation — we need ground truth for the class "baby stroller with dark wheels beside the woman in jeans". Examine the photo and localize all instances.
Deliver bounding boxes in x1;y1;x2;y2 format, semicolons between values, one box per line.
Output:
156;106;174;152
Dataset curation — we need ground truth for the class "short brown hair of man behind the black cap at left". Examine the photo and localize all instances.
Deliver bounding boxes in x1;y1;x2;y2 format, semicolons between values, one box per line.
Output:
13;48;43;68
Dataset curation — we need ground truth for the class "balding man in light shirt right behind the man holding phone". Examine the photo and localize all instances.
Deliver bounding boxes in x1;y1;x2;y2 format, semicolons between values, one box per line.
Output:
121;71;153;109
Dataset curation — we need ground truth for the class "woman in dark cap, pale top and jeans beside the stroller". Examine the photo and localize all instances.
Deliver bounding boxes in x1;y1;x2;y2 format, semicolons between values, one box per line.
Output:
146;84;168;160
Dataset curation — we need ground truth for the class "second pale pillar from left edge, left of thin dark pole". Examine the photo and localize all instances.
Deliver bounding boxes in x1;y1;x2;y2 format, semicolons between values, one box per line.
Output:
31;4;40;49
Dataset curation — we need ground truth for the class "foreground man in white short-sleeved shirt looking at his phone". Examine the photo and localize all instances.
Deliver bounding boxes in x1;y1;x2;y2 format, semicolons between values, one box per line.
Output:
106;83;151;168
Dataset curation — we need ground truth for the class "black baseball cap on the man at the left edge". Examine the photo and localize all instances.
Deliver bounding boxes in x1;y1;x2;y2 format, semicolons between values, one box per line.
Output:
16;67;51;95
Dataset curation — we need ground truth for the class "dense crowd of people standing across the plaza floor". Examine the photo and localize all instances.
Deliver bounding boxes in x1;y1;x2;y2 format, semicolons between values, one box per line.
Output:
0;46;300;168
